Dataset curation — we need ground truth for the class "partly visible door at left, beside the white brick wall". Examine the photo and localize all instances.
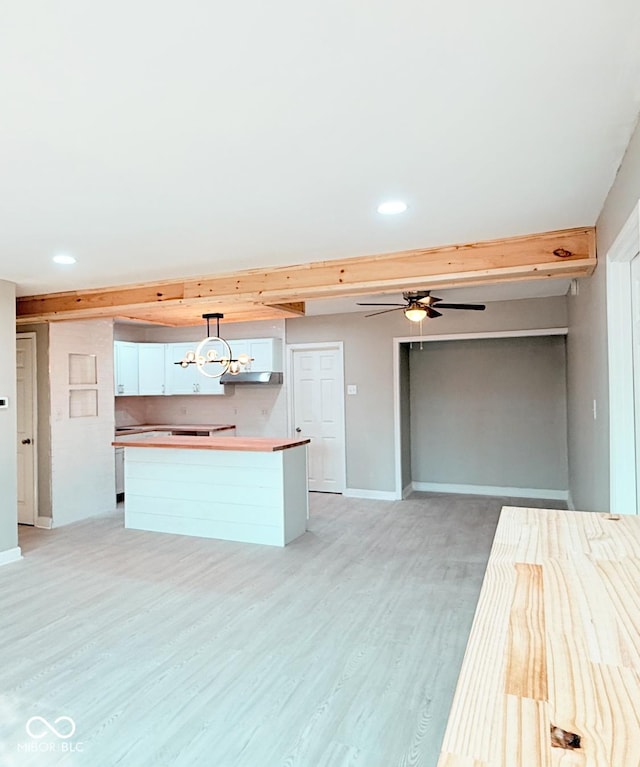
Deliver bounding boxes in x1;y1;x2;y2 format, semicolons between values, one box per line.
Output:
16;336;37;525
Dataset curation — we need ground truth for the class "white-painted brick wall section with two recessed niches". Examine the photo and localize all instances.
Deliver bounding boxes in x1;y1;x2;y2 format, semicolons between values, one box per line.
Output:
49;320;115;527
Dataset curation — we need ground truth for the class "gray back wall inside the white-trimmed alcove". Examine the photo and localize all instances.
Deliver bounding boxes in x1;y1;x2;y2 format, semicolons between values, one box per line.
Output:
410;336;568;491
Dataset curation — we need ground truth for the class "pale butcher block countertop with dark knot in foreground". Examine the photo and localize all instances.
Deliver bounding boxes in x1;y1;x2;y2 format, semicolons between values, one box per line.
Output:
438;507;640;767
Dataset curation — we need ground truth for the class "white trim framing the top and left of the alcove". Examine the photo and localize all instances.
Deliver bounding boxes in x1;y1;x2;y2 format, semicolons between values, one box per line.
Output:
392;327;569;501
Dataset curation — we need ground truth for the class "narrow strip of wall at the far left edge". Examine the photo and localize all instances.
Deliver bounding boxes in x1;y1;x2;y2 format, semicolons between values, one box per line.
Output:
0;280;19;561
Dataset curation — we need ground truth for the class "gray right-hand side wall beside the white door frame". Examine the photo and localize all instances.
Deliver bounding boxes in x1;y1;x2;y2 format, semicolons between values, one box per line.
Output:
567;115;640;511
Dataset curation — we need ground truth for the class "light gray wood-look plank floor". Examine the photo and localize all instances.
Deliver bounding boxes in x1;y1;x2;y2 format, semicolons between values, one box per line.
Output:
0;493;558;767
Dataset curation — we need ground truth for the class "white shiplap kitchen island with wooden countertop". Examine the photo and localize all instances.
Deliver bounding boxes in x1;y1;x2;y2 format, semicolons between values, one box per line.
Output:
114;436;309;546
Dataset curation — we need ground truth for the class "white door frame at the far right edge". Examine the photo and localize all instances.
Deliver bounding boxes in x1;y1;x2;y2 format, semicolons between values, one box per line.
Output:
606;202;640;514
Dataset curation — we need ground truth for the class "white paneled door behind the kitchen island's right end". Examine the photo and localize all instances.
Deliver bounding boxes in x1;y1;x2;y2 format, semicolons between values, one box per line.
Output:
291;344;345;493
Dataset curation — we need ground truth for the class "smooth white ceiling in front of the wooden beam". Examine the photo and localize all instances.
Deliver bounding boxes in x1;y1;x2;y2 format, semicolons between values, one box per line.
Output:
0;0;640;295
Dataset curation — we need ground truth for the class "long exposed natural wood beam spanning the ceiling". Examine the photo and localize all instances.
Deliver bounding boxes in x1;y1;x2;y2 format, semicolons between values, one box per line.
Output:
17;227;596;324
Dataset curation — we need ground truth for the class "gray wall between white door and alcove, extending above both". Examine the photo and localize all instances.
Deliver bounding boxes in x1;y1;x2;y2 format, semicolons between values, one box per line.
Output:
286;296;567;492
